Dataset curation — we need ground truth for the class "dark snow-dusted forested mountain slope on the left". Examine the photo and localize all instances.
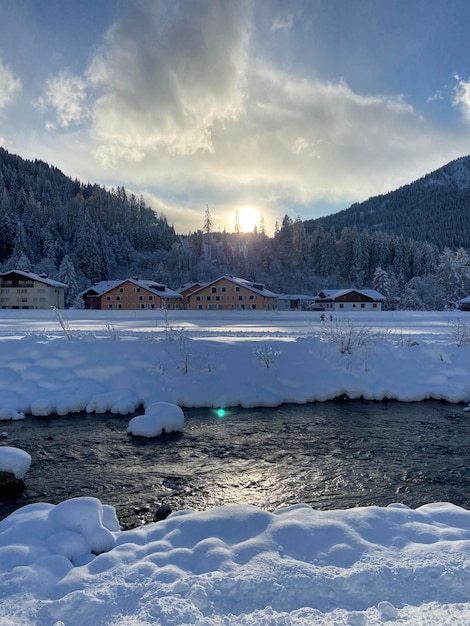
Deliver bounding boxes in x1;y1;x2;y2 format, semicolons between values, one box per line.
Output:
0;148;177;302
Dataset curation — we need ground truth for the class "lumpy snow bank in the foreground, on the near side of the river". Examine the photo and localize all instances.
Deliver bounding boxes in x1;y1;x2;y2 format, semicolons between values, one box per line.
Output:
0;498;470;626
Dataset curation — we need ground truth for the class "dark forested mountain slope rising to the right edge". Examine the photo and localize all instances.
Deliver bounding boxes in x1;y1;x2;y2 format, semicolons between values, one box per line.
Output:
304;156;470;249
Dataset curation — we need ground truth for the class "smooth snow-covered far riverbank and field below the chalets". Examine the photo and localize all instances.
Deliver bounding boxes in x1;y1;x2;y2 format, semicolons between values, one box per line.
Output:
0;311;470;420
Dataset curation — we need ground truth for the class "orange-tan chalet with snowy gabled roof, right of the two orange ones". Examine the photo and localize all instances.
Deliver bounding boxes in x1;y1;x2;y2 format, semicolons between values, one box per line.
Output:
187;274;277;311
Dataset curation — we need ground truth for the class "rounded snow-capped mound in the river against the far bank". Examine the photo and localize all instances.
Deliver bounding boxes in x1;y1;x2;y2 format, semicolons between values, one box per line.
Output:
127;402;184;437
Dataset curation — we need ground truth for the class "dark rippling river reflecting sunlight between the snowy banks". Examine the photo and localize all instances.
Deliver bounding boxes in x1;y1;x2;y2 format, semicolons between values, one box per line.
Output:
0;400;470;528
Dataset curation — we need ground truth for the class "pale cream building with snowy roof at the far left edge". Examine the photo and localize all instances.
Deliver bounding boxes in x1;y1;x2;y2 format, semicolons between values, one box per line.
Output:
0;270;68;309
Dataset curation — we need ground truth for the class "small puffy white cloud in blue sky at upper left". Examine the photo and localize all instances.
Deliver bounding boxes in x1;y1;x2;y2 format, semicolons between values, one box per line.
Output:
37;70;89;130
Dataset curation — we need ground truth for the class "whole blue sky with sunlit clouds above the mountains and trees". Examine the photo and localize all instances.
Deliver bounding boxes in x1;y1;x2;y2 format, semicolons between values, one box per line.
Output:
0;0;470;234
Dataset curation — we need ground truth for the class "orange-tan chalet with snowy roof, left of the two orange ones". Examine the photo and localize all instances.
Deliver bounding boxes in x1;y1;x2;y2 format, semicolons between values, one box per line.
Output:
80;277;182;311
